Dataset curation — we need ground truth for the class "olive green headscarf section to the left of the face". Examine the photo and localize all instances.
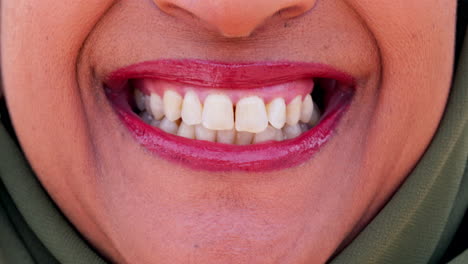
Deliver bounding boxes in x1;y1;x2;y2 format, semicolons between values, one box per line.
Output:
0;124;105;264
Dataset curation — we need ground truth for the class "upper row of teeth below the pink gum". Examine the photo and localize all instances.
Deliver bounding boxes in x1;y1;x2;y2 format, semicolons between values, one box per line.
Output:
135;89;319;133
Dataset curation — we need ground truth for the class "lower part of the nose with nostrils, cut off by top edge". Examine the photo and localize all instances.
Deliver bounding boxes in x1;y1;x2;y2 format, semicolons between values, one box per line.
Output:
153;0;317;37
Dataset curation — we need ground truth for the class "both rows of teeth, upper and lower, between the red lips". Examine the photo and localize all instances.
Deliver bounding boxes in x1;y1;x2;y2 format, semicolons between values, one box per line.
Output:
134;89;321;145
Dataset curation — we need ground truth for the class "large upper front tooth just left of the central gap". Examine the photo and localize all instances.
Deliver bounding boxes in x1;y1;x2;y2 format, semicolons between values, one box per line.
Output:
202;94;234;130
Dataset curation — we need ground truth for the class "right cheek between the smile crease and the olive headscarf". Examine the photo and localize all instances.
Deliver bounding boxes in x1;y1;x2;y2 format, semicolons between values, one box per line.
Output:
351;0;456;197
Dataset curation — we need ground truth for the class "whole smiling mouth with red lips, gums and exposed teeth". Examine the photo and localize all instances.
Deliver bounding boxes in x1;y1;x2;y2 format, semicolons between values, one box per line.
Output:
104;60;355;172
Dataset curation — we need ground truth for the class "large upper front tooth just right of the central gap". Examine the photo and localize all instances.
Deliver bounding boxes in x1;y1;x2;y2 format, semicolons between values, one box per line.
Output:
236;96;268;133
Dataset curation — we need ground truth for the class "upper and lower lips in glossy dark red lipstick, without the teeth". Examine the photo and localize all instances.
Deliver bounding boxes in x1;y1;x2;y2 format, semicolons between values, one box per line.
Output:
104;60;355;172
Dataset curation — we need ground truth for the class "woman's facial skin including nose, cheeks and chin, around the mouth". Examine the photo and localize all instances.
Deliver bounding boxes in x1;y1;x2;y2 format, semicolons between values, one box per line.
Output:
1;0;456;263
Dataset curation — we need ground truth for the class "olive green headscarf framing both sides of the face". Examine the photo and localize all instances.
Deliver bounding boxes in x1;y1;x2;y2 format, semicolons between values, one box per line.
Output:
0;25;468;264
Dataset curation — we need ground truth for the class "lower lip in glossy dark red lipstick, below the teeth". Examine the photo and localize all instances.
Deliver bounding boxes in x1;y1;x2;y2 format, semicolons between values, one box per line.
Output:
108;86;352;172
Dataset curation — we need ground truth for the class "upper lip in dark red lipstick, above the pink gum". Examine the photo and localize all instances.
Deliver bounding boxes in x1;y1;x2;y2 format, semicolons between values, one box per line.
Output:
105;59;355;89
